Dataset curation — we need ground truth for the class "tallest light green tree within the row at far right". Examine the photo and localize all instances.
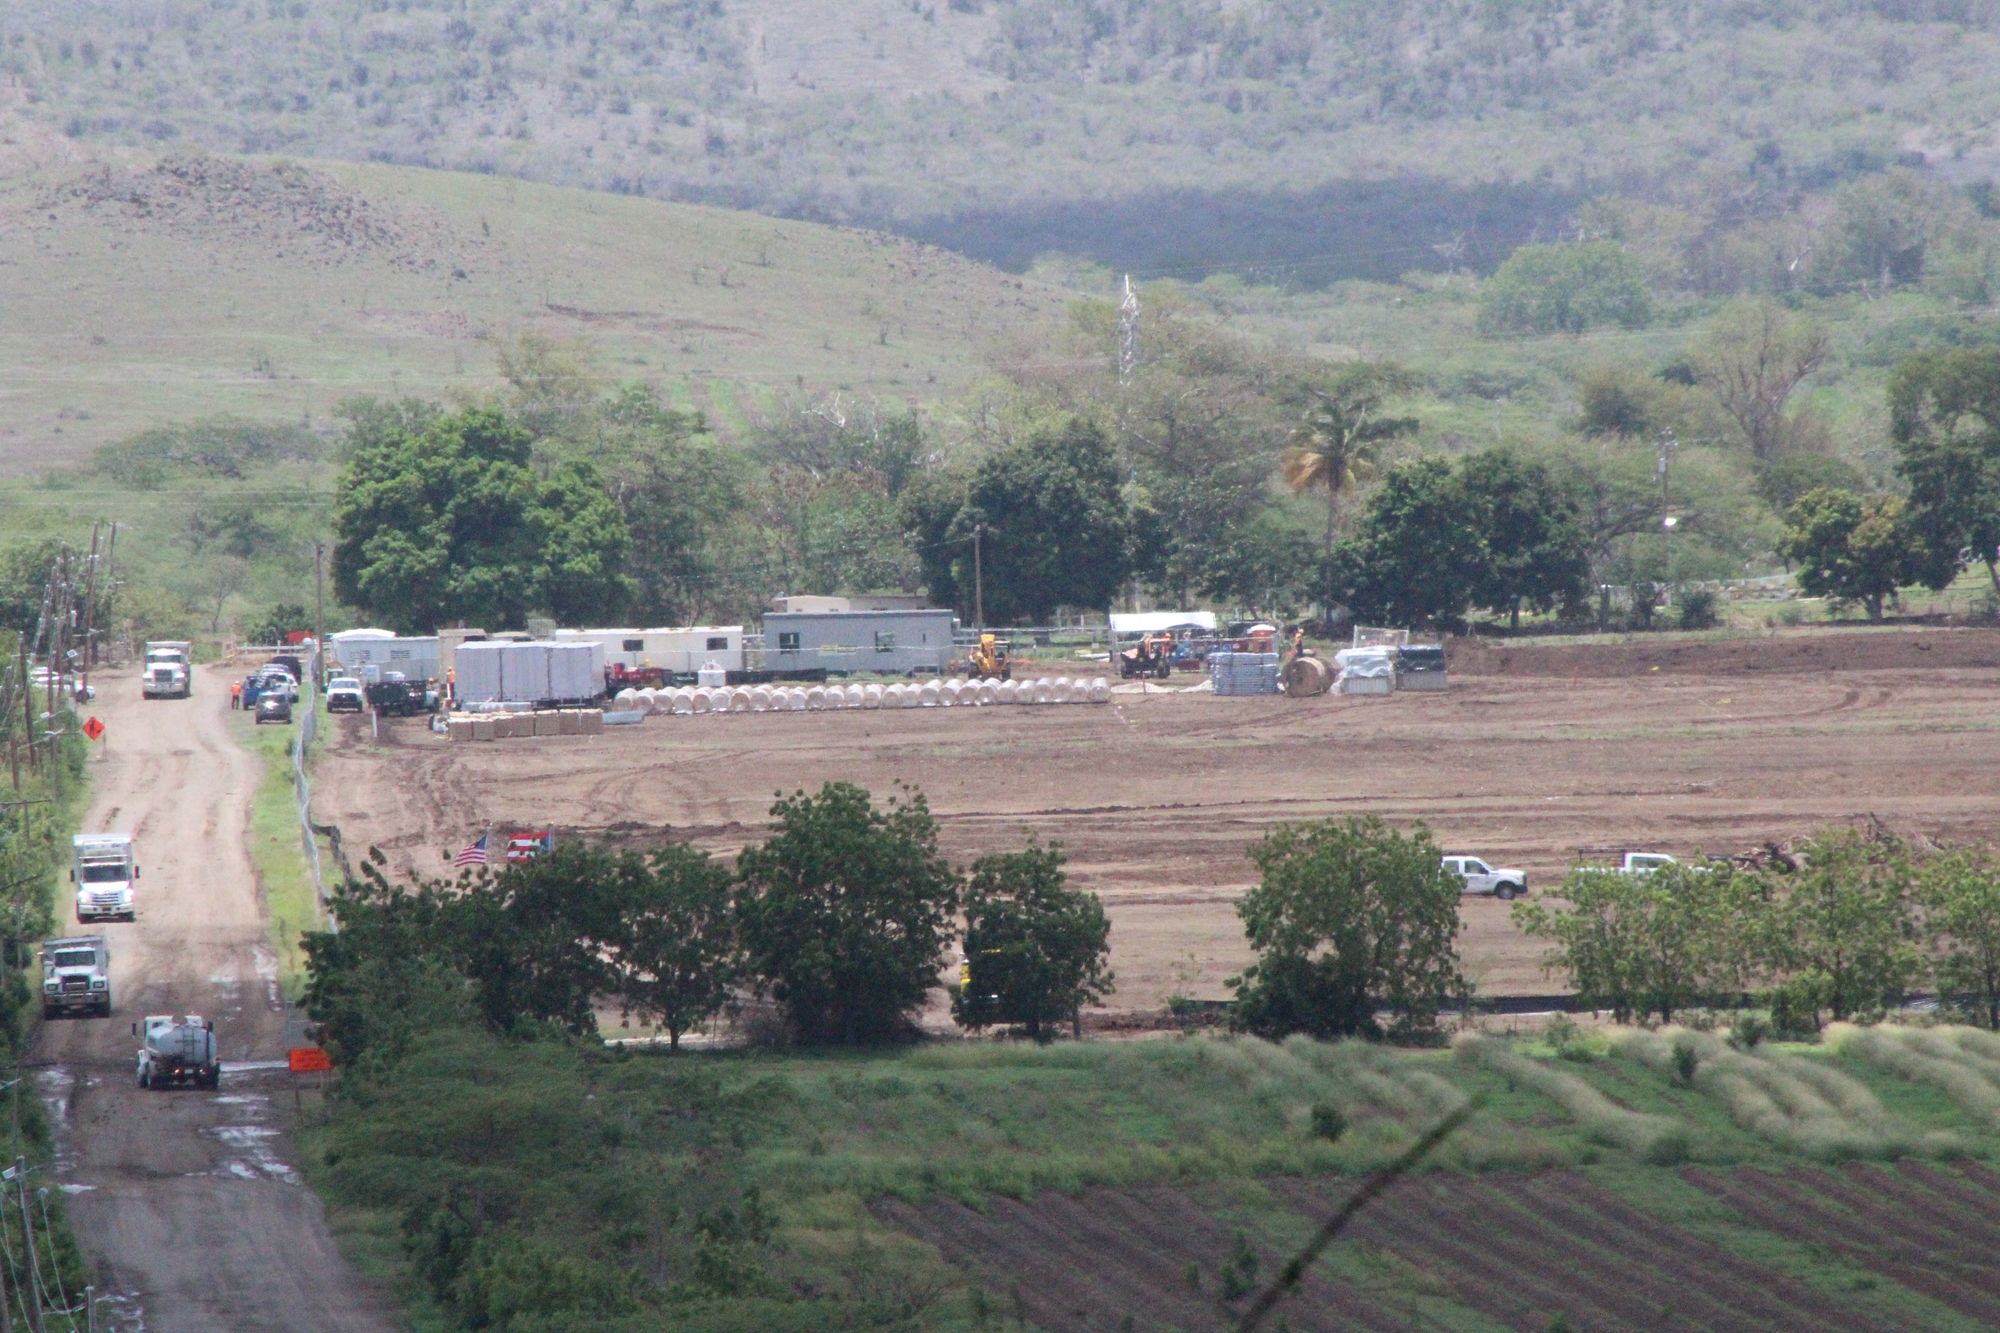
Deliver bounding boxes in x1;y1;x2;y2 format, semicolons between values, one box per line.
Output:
1764;829;1920;1023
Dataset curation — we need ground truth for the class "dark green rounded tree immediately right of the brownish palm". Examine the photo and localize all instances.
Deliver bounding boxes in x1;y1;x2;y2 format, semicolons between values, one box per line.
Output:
1332;458;1486;624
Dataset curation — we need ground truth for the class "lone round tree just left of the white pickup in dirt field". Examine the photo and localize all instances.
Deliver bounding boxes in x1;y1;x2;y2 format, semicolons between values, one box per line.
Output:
1230;815;1470;1037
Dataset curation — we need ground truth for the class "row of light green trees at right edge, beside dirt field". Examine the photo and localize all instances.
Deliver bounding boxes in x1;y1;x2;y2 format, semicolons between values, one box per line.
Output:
1514;829;2000;1033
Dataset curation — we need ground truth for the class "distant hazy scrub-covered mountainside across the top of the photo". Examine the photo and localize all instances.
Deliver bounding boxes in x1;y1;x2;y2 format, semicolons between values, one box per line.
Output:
11;0;2000;280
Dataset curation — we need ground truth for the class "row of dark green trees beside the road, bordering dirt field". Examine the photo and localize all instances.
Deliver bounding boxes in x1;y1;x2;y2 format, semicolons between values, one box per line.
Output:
306;783;1112;1061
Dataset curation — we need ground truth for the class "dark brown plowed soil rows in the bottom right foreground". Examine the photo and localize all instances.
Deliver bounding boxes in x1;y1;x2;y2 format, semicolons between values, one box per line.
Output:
878;1163;2000;1333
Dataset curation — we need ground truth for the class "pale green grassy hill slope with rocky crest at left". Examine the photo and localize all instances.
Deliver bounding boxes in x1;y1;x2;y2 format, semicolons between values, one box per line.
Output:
0;141;1066;472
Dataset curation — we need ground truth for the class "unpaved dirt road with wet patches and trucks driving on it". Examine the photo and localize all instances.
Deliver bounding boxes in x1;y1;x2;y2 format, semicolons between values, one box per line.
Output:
36;669;394;1333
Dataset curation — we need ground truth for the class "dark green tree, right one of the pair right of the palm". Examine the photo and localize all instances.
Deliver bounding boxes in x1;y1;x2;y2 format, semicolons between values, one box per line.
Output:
1458;448;1590;626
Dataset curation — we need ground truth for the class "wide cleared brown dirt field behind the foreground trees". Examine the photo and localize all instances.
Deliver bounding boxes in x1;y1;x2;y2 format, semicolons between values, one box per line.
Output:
316;630;2000;1011
